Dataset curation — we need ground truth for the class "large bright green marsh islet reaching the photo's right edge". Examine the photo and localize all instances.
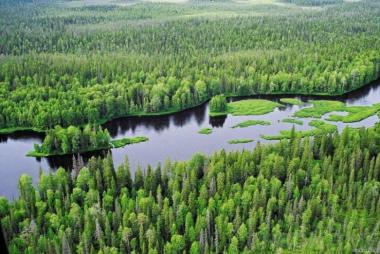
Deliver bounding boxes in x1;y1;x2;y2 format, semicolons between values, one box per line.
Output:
294;100;380;123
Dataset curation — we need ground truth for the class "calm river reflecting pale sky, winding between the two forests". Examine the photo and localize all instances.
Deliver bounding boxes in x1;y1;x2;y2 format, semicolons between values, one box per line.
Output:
0;80;380;199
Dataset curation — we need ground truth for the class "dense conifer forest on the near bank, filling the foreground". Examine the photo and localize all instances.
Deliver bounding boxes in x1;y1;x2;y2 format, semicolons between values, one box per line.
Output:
0;124;380;253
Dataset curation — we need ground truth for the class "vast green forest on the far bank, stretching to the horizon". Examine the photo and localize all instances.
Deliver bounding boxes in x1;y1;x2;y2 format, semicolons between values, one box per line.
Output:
0;0;380;132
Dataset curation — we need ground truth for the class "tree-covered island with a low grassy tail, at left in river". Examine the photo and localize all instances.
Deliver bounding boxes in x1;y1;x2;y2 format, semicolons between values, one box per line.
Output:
27;125;148;157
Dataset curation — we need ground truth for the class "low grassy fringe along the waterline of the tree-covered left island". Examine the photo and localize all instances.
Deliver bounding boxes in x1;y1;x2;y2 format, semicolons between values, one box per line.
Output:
26;136;149;158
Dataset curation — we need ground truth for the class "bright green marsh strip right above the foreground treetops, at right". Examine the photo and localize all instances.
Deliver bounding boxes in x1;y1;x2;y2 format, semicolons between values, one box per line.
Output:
261;120;337;140
